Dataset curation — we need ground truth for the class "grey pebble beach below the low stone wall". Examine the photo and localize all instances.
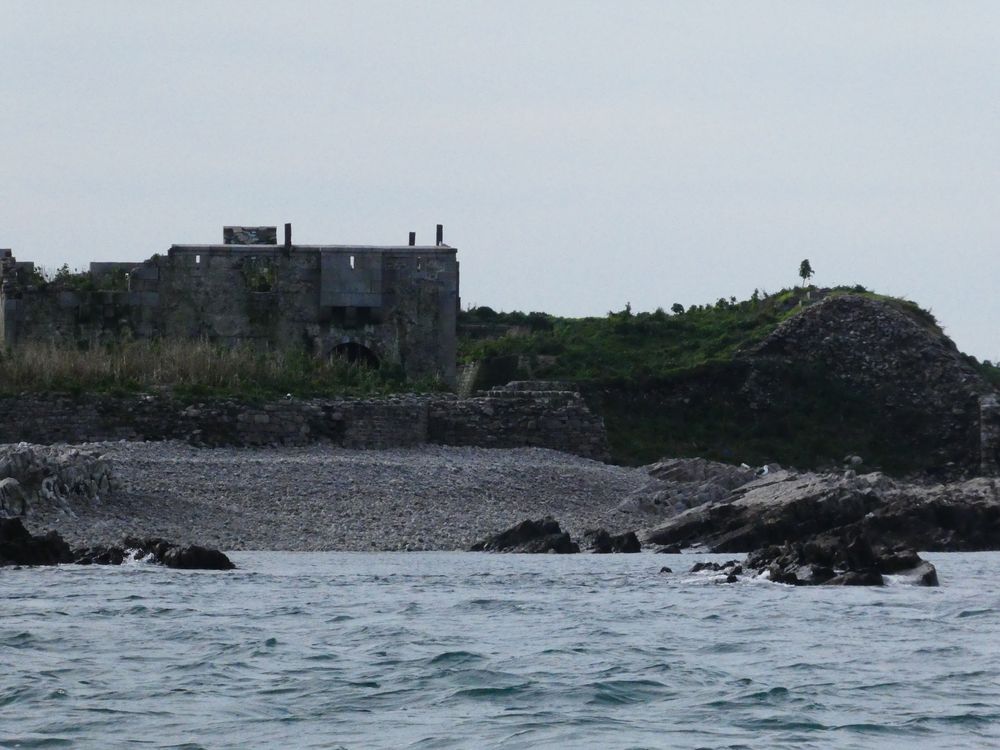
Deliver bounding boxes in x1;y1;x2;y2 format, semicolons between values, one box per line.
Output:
24;441;649;551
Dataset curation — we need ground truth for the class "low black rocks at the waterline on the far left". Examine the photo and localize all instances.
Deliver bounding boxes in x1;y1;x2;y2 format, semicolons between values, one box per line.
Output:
0;517;236;570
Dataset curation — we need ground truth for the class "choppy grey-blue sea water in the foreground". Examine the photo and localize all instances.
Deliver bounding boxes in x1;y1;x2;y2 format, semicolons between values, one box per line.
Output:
0;553;1000;749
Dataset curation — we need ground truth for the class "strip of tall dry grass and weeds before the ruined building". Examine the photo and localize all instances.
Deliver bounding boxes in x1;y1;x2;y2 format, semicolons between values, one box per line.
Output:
0;341;441;400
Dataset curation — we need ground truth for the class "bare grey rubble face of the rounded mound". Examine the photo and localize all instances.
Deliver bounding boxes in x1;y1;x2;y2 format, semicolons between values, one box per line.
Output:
740;294;992;472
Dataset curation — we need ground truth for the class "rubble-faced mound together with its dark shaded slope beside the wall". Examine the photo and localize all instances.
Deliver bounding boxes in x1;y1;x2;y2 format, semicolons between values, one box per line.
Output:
582;290;1000;476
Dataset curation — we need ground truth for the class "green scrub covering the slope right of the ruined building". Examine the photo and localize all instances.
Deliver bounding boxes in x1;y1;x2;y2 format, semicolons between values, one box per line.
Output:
459;284;1000;472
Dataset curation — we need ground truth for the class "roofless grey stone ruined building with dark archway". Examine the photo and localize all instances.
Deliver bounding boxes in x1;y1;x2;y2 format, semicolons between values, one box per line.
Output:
0;224;460;383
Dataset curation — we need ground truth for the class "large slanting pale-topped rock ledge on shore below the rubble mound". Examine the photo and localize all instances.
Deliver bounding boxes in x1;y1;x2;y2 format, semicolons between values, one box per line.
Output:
643;471;1000;552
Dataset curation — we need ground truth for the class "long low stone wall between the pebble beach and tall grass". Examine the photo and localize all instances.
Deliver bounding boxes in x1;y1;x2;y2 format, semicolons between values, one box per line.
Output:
0;390;607;460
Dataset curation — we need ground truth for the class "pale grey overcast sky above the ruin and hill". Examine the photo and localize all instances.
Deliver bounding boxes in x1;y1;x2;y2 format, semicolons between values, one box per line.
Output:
0;0;1000;360
